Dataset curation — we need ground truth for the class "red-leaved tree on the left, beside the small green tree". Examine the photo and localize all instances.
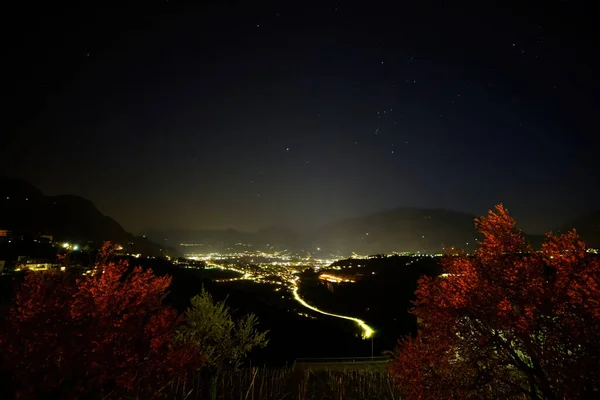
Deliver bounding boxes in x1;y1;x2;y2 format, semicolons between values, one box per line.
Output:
0;242;203;398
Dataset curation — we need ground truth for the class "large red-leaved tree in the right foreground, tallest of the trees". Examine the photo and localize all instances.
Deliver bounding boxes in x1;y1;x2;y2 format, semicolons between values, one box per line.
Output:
390;205;600;399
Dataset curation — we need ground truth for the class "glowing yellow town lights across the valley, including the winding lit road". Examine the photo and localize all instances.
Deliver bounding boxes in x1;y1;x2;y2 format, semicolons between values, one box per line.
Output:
5;231;598;339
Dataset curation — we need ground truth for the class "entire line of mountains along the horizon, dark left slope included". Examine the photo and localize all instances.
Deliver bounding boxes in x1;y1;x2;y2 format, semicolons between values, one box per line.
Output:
0;176;600;255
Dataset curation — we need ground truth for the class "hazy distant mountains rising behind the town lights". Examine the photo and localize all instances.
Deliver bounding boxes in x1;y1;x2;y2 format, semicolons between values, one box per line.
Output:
145;207;600;257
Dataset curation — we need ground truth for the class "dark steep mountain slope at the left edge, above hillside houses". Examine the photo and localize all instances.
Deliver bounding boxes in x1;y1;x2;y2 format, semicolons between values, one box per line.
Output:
0;177;169;256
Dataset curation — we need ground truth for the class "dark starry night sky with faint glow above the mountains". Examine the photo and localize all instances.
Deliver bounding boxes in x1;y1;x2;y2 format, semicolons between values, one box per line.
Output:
0;0;600;233
